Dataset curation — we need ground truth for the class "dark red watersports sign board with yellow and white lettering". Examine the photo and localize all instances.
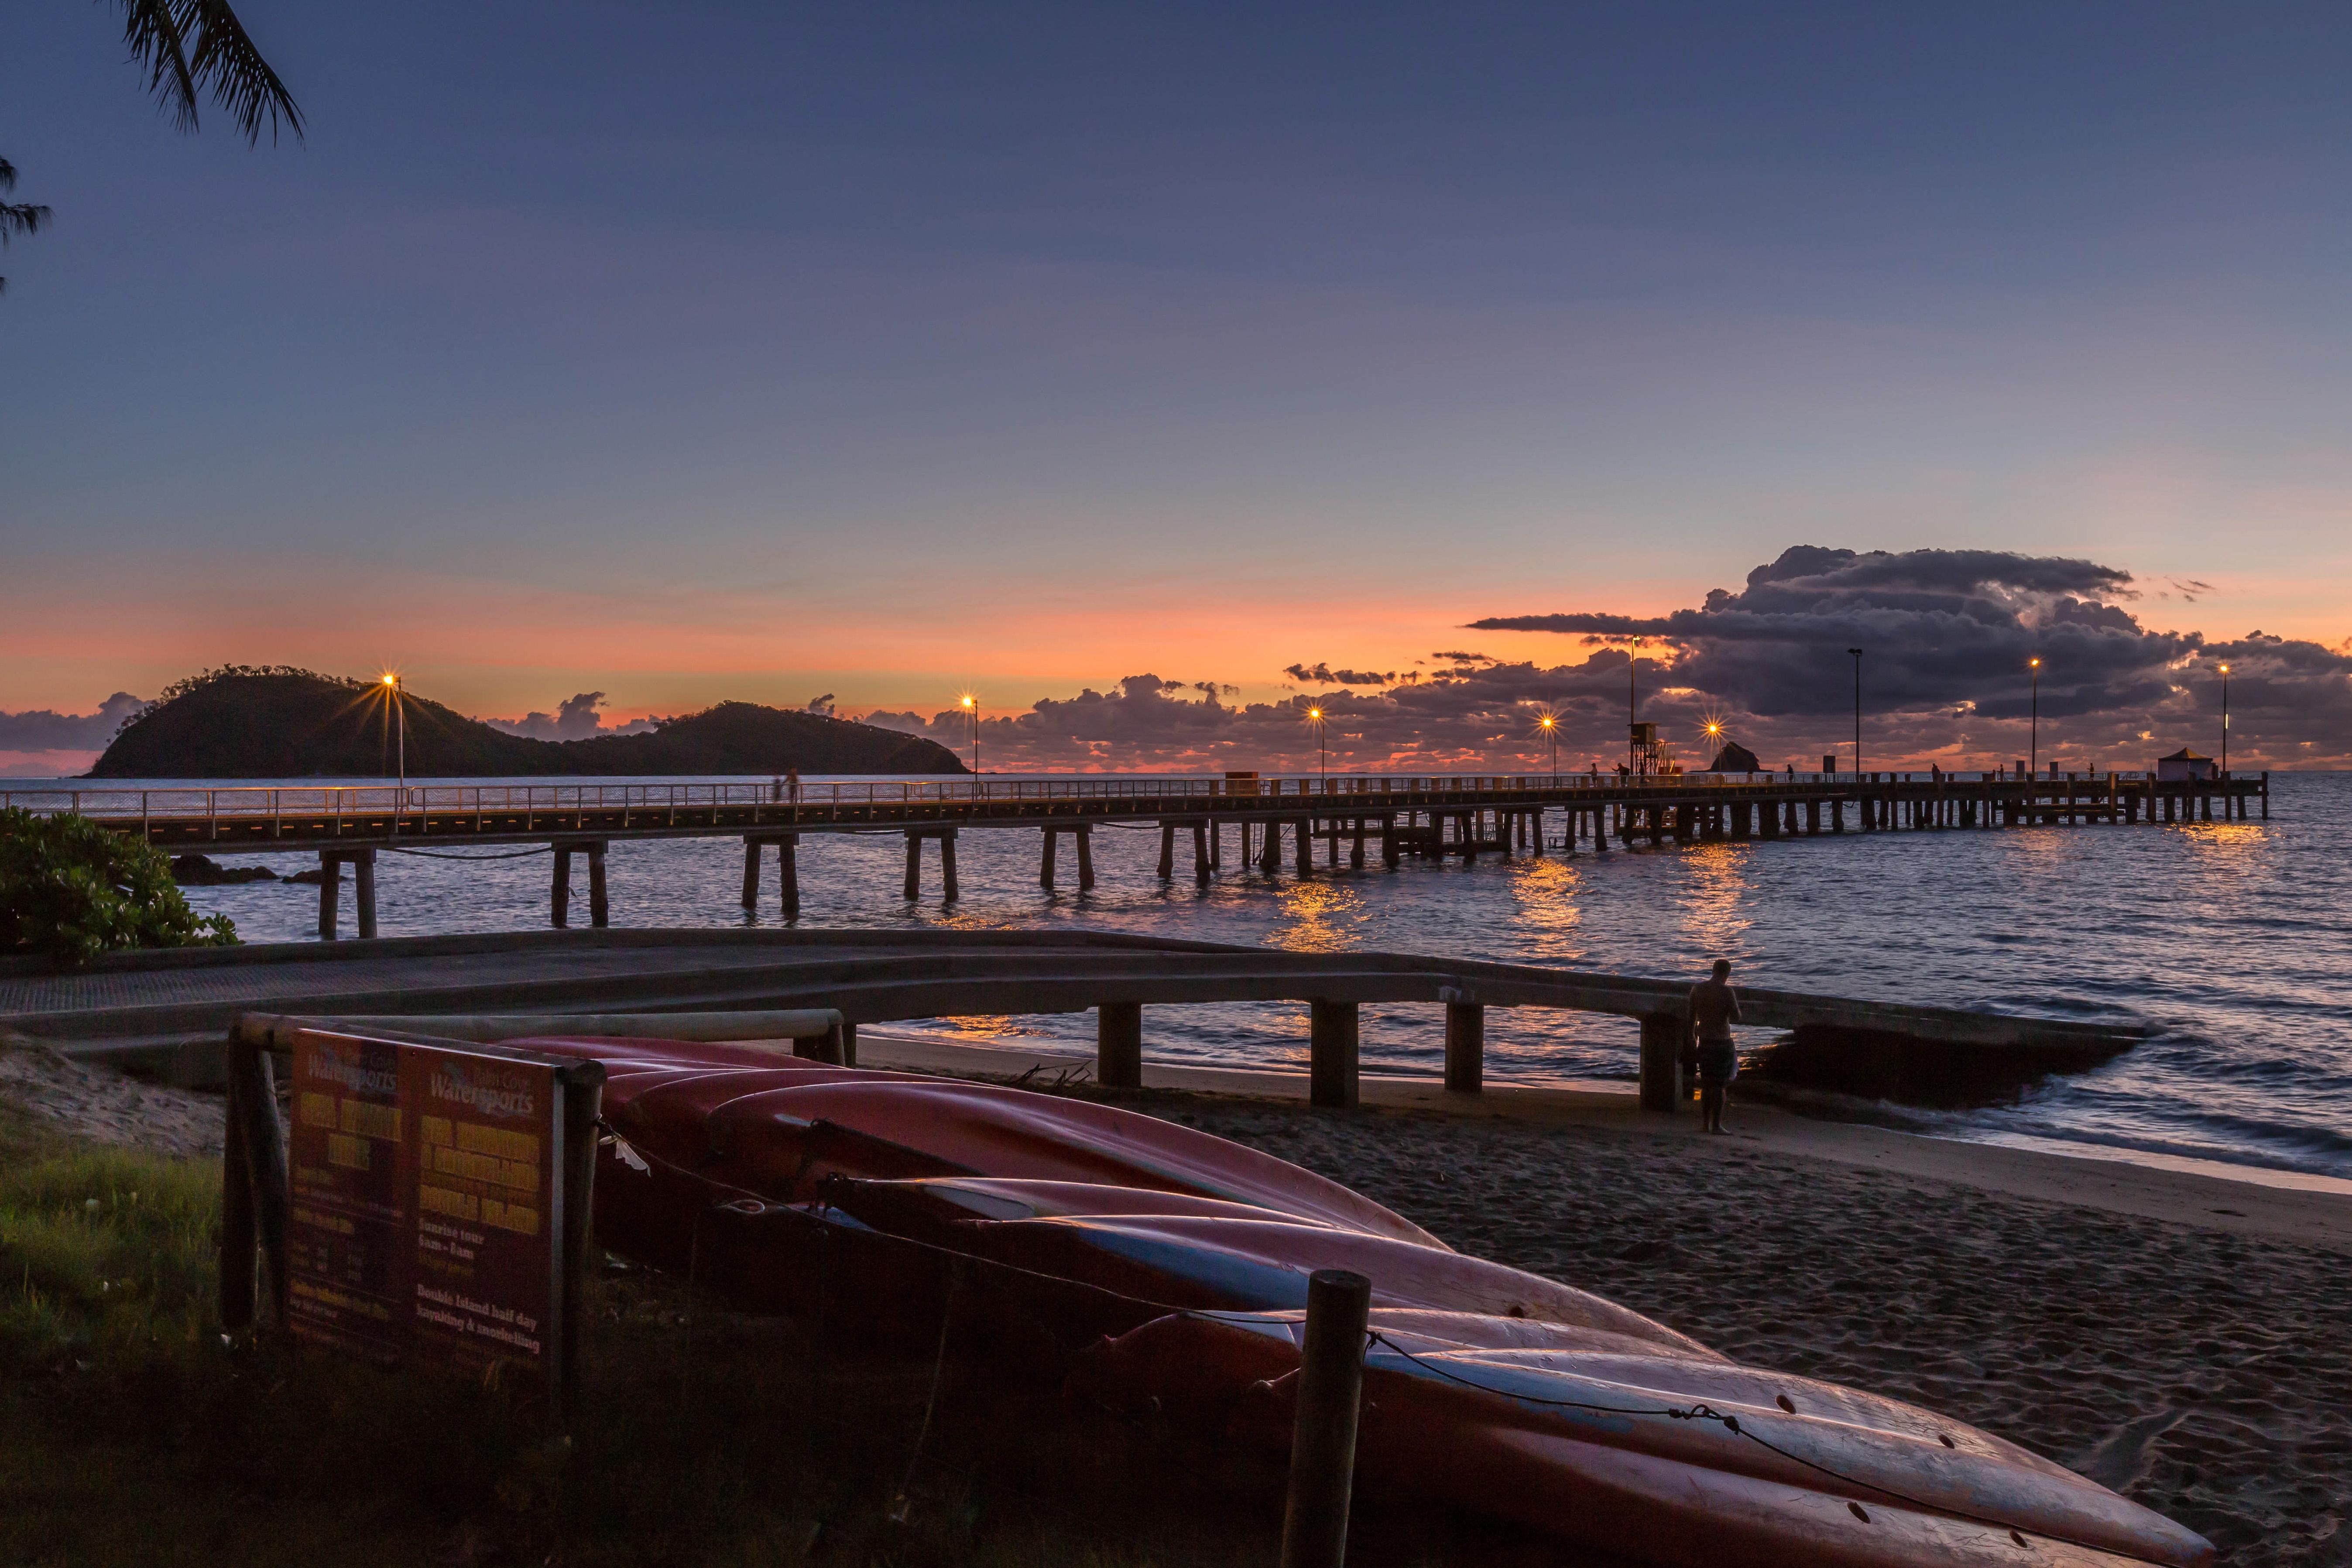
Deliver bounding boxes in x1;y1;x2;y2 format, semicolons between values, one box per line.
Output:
285;1029;567;1387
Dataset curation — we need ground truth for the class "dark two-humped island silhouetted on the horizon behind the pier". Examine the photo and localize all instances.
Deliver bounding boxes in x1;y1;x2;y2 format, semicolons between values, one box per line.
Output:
89;668;969;778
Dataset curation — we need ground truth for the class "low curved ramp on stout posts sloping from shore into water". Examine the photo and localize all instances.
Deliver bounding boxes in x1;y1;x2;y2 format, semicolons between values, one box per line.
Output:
0;929;2145;1112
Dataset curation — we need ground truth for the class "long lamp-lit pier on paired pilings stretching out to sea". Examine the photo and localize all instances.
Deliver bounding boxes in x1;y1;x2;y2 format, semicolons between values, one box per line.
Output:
0;771;2270;940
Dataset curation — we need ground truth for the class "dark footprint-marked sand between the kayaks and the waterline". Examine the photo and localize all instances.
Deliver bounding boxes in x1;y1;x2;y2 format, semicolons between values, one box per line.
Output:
861;1032;2352;1563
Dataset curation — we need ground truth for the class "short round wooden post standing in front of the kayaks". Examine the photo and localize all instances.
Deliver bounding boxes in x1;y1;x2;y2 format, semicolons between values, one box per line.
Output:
1282;1269;1371;1568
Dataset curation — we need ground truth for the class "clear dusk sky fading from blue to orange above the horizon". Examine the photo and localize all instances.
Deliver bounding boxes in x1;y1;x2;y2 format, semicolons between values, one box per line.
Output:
0;0;2352;773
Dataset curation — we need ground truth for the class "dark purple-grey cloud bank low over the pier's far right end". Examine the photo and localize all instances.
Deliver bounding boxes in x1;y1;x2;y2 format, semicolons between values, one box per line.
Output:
868;546;2352;773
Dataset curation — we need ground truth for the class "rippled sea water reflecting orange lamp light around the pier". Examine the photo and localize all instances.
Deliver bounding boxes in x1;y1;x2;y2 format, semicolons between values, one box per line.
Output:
7;773;2352;1178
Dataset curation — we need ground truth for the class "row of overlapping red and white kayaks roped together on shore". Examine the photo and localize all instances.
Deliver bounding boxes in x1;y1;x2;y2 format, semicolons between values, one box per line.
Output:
518;1039;2213;1568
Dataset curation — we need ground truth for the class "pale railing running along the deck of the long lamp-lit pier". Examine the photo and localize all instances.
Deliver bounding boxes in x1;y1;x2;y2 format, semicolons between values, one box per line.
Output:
0;771;2230;823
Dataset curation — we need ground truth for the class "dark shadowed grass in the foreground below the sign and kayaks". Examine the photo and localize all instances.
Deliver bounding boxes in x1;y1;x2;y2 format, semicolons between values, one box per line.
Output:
0;1138;1555;1568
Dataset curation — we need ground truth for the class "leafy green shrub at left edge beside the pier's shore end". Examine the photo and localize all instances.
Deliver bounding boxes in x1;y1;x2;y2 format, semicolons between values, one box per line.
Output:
0;809;237;964
